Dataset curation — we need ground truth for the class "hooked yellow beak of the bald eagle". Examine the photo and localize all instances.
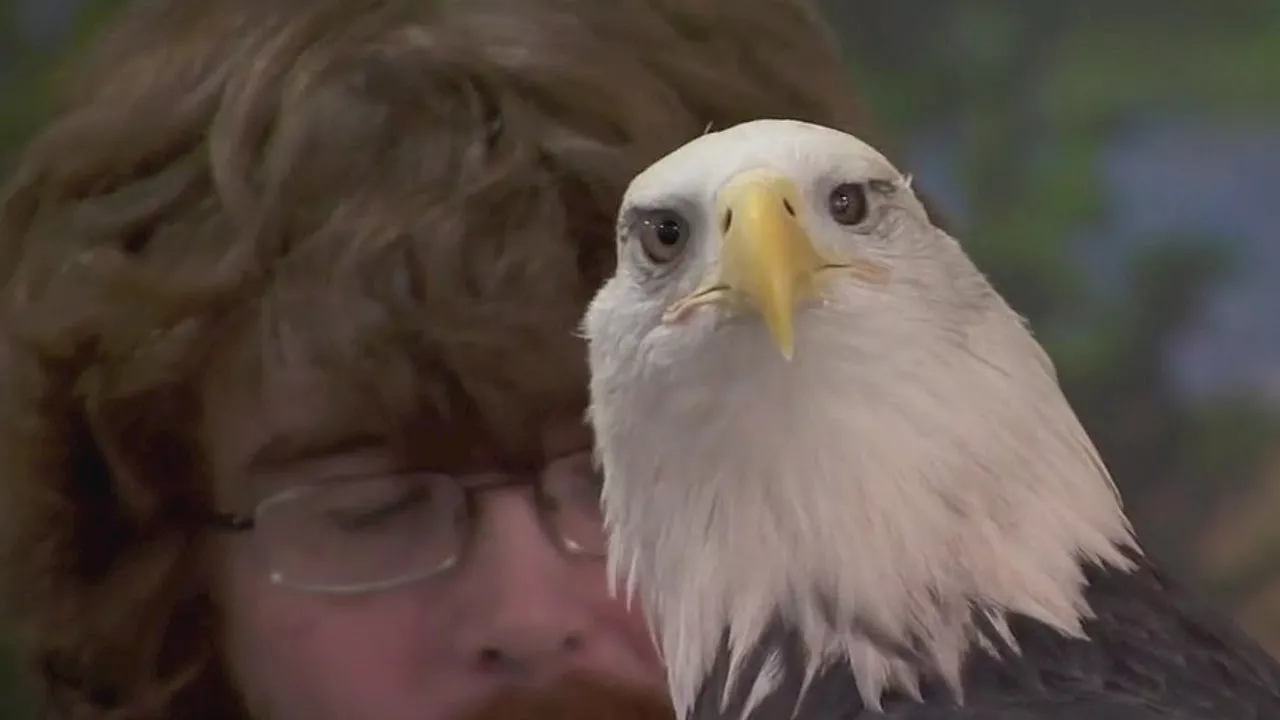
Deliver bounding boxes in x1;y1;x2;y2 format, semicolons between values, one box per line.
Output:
717;173;829;360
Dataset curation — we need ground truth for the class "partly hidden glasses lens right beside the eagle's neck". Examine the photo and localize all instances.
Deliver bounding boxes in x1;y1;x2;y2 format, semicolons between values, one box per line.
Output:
543;452;608;556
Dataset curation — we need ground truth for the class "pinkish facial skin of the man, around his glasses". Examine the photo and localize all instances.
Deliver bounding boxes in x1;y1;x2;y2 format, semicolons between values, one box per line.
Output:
202;356;663;720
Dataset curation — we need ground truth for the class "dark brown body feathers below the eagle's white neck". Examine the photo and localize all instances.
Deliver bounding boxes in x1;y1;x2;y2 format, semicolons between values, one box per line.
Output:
691;548;1280;720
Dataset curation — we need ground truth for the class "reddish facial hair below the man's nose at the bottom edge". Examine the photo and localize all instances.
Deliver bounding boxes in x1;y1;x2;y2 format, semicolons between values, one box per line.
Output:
465;675;676;720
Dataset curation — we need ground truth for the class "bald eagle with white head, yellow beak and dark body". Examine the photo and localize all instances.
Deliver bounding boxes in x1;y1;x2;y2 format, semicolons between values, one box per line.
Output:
584;120;1280;720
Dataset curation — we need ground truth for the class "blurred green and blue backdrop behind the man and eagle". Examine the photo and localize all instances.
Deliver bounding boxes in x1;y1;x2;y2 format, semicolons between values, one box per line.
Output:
0;0;1280;719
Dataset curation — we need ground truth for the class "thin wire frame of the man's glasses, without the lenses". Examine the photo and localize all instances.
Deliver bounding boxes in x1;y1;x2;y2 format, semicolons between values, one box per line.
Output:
209;473;607;596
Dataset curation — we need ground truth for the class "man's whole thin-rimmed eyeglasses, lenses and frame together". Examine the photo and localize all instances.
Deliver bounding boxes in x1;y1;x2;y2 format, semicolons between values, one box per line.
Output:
214;452;607;594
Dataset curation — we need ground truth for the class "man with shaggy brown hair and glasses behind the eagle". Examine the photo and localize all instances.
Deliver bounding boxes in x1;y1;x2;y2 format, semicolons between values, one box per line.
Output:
0;0;865;720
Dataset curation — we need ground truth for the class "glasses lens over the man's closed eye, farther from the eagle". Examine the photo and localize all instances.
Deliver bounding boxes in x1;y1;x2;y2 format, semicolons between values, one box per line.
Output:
257;474;465;591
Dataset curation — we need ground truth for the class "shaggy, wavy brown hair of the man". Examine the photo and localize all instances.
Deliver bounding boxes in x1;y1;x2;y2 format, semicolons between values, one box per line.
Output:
0;0;863;720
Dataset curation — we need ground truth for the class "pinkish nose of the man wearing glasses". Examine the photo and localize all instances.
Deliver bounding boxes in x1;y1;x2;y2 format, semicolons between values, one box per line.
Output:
463;488;591;679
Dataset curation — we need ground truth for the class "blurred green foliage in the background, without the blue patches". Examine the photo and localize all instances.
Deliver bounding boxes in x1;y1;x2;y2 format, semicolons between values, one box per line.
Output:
0;0;1280;717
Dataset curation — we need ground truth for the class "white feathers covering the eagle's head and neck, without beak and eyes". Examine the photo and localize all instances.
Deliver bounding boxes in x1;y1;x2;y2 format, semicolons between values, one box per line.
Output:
584;120;1135;715
